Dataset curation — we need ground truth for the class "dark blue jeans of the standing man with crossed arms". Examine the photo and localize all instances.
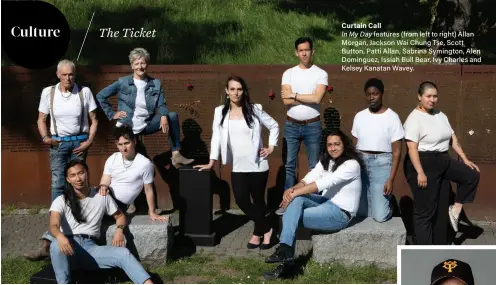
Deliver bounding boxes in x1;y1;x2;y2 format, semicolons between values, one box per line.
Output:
284;121;322;190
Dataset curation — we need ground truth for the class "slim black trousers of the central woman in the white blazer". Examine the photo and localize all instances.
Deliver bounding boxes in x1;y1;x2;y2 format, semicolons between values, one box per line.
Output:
231;171;271;236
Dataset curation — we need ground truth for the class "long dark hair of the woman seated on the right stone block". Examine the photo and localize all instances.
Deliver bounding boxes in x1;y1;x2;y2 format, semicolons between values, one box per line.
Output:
320;129;364;172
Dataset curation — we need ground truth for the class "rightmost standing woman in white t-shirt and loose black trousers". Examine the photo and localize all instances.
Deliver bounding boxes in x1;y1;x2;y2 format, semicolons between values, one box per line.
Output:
404;81;480;245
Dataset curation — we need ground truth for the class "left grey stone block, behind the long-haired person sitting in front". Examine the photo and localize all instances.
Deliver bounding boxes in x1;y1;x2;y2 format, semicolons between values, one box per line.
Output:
106;215;173;265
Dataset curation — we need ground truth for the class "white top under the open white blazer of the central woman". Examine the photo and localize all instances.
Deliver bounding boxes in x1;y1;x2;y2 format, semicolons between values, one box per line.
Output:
227;119;269;172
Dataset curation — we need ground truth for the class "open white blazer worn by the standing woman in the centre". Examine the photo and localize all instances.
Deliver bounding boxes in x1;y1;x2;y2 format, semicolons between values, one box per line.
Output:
210;104;279;164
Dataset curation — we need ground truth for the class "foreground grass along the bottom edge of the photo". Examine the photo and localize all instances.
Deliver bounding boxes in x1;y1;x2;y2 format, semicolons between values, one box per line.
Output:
1;253;396;284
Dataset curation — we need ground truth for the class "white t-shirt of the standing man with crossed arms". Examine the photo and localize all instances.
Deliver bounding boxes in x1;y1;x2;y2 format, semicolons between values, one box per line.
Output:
281;64;328;120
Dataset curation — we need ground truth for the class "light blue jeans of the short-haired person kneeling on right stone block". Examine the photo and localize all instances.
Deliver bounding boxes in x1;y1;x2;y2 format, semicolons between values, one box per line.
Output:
358;152;393;223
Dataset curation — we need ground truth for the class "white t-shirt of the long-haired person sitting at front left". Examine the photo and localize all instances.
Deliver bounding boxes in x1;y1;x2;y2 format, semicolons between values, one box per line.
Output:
50;188;118;238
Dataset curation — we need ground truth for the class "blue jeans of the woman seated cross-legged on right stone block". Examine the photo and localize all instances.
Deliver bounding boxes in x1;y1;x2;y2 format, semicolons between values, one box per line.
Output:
279;194;350;248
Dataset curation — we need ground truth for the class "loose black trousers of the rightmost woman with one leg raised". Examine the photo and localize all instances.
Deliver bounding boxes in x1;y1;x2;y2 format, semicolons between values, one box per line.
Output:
404;152;480;245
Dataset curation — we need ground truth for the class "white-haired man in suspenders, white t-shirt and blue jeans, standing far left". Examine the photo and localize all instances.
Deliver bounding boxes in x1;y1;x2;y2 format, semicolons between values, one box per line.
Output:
24;59;98;260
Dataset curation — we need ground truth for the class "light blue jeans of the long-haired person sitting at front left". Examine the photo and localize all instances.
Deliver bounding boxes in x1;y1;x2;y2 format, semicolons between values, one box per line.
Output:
50;237;150;284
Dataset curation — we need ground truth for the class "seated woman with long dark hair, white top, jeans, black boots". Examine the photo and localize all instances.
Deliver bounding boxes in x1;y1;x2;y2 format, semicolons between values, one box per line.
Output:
265;130;363;278
